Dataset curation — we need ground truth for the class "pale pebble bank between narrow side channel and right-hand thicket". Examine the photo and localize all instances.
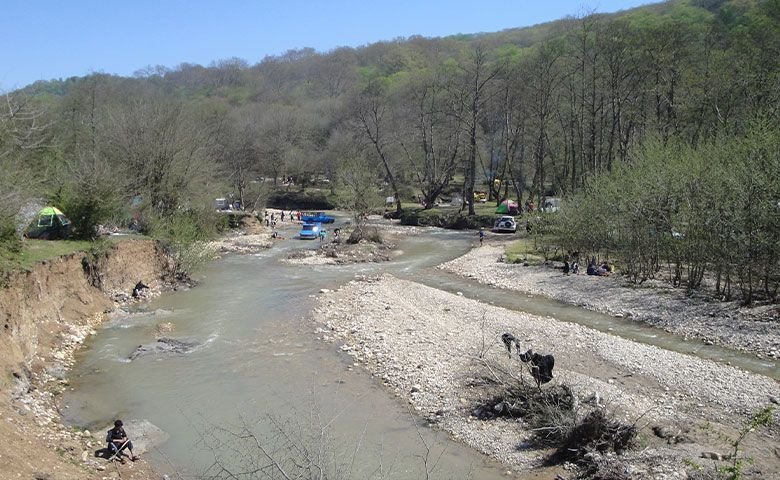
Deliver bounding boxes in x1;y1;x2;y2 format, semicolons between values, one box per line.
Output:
440;241;780;361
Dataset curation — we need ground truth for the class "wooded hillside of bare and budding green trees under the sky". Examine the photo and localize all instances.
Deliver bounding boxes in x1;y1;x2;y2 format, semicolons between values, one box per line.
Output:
0;0;780;296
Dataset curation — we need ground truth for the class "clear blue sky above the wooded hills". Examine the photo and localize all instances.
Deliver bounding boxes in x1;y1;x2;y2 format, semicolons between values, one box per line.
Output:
0;0;650;91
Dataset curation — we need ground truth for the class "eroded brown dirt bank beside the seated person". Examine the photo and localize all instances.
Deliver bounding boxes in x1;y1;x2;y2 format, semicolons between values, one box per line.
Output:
0;240;168;480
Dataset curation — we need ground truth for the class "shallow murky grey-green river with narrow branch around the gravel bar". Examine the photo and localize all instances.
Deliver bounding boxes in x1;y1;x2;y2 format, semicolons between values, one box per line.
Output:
63;219;776;480
